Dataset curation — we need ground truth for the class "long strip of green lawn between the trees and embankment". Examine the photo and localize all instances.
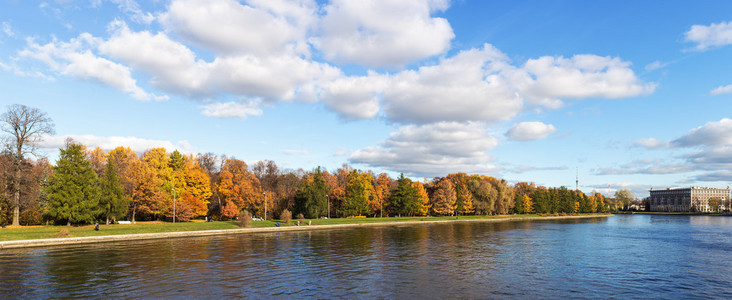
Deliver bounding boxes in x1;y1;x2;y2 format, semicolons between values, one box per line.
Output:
0;214;608;241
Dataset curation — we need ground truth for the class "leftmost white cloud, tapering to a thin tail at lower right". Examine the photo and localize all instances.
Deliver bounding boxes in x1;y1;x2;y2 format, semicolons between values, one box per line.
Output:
19;33;168;100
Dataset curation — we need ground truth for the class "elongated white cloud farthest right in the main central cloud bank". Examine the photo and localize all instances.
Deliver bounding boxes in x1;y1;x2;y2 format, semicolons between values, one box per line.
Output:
519;54;656;108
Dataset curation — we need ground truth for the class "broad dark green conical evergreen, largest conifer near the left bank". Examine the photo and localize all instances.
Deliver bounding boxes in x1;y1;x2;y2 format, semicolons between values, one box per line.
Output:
46;141;99;226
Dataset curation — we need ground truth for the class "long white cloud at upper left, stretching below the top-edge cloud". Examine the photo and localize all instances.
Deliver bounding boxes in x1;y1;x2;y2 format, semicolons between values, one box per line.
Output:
99;22;342;101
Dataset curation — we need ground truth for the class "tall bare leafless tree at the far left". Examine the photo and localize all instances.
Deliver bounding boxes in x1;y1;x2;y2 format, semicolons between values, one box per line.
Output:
0;104;54;225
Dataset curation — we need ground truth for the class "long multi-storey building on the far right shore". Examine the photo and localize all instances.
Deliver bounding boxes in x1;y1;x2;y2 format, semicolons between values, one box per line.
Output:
649;186;730;212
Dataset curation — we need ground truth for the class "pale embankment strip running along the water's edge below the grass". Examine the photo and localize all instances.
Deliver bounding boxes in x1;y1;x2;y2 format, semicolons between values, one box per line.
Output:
0;214;613;250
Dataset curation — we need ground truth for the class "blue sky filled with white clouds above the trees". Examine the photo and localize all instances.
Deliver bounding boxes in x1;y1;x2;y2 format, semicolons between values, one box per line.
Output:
0;0;732;198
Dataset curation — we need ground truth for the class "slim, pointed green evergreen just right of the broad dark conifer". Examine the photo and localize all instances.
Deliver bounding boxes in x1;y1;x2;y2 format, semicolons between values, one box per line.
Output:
99;158;130;224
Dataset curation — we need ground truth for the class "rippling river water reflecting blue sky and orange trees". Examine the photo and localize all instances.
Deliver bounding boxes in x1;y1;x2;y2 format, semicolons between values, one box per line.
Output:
0;215;732;299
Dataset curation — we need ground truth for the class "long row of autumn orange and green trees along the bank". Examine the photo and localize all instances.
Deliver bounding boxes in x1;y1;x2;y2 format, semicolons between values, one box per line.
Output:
0;141;608;225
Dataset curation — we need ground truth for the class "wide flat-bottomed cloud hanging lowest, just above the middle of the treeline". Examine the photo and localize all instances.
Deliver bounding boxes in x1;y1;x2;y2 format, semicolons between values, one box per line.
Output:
349;122;498;177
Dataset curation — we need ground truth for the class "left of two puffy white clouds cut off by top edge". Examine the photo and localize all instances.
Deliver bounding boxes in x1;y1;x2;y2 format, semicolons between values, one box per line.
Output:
160;0;317;55
